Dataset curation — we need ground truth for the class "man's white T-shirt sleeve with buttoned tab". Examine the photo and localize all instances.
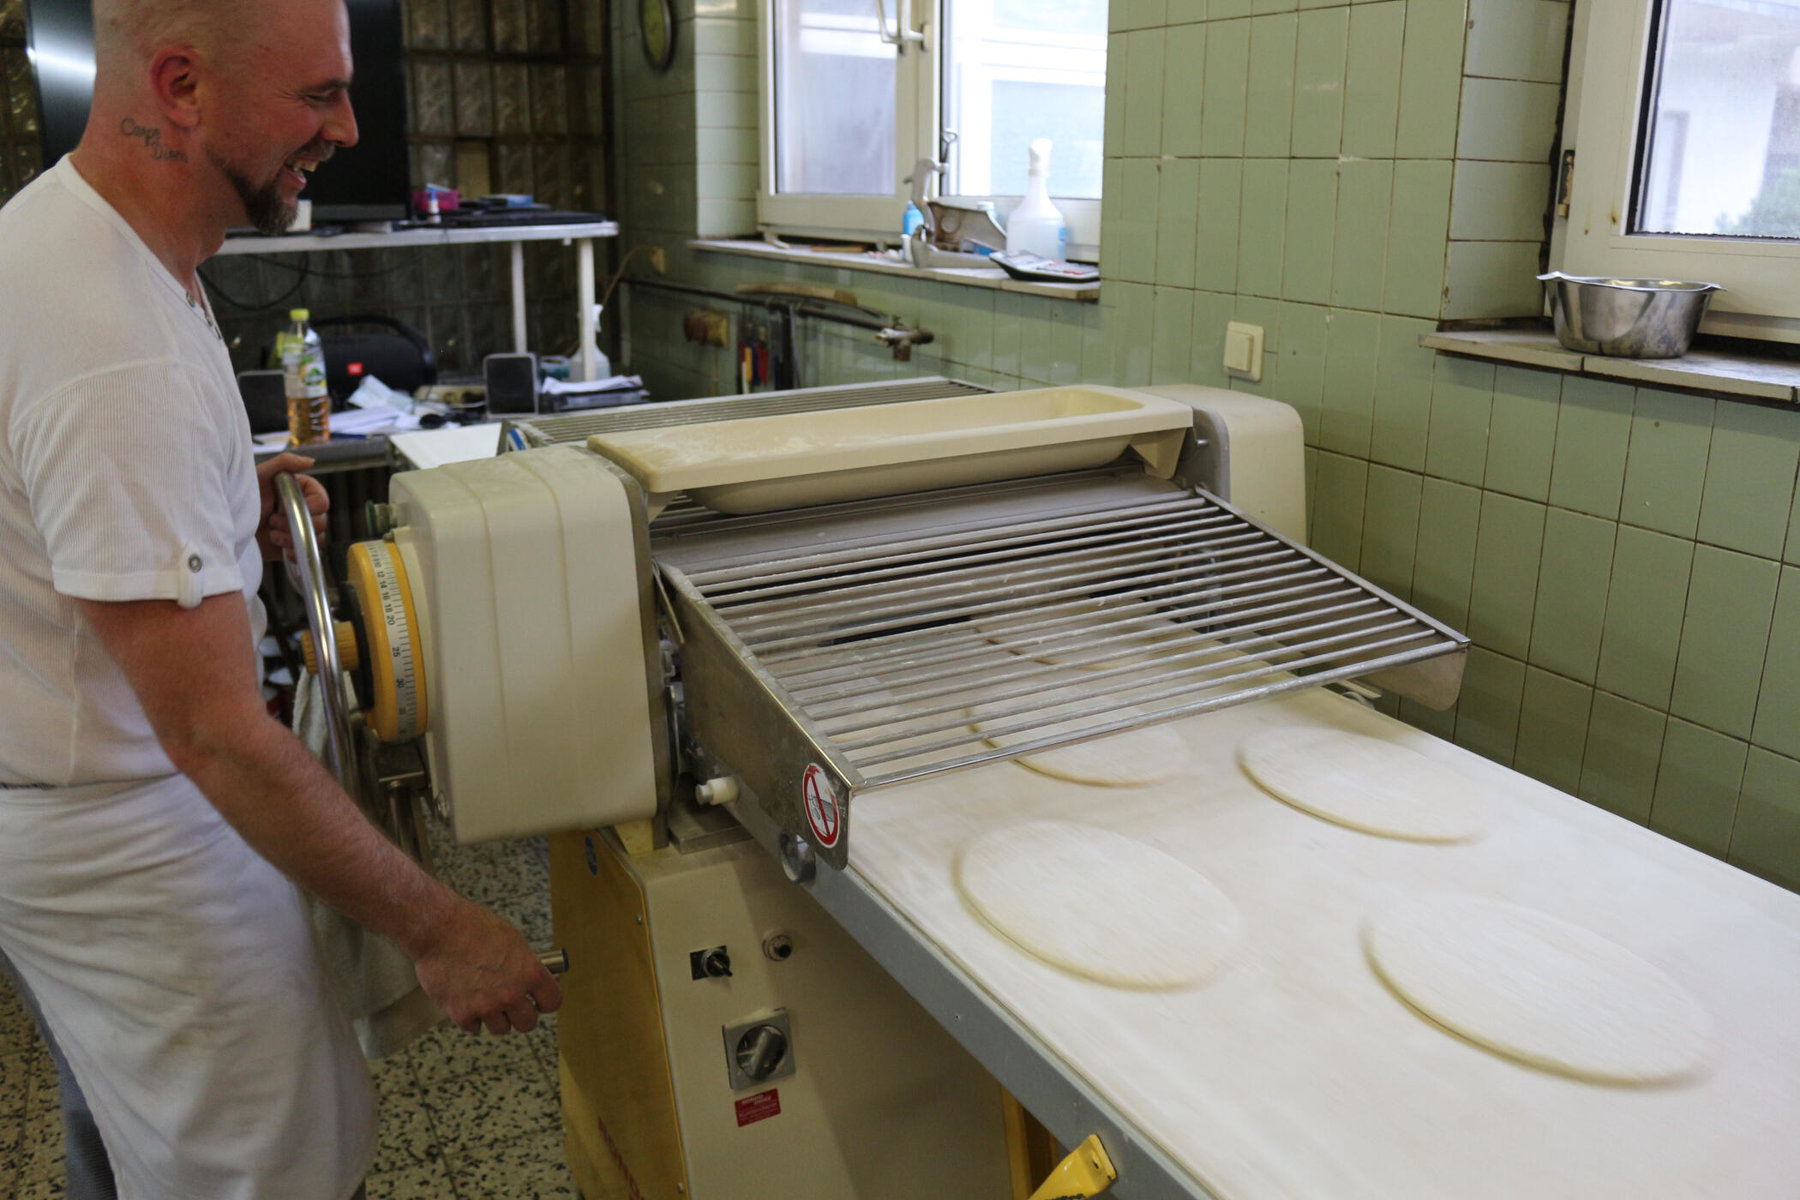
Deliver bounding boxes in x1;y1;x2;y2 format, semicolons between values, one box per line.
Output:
13;362;243;608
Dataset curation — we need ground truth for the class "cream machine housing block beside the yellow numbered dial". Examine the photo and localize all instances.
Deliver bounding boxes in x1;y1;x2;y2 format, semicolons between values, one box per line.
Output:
392;446;659;842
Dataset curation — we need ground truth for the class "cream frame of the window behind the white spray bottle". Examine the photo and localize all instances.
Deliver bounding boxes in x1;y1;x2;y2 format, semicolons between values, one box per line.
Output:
756;0;1100;259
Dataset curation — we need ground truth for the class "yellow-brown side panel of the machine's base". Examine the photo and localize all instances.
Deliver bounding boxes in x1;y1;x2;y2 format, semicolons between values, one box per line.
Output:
551;831;688;1200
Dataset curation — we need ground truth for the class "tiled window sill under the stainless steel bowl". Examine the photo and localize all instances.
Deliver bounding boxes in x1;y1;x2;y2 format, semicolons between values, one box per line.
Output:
1418;329;1800;405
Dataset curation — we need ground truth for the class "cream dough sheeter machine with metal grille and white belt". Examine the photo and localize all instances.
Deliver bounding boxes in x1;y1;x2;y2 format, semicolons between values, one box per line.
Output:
277;380;1800;1200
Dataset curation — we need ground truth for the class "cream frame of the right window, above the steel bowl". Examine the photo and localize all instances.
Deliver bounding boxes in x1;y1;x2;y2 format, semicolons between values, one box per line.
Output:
1550;0;1800;342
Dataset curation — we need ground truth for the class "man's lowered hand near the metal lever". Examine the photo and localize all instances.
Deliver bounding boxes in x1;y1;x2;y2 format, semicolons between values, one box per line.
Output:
412;900;562;1033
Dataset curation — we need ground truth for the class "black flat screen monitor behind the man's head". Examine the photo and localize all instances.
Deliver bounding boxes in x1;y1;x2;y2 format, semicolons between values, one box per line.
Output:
25;0;410;225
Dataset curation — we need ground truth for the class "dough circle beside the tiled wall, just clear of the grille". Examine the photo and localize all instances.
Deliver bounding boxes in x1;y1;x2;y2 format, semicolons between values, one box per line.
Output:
1238;725;1487;842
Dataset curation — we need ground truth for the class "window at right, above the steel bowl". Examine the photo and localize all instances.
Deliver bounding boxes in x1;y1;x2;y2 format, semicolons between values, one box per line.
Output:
1553;0;1800;340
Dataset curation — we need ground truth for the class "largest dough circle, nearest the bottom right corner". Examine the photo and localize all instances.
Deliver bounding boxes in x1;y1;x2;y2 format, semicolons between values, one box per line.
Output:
1363;896;1714;1085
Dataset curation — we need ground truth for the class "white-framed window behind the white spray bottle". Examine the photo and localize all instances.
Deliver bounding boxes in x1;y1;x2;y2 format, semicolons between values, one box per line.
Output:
758;0;1107;257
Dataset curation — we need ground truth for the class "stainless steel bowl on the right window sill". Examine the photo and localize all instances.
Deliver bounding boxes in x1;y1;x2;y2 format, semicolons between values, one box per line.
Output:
1539;272;1724;358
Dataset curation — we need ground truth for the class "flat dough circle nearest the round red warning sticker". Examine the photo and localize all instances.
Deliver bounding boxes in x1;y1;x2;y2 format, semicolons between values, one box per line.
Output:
956;820;1242;990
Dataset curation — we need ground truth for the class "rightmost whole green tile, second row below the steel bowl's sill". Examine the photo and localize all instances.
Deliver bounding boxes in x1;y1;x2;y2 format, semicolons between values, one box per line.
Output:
1669;545;1780;738
